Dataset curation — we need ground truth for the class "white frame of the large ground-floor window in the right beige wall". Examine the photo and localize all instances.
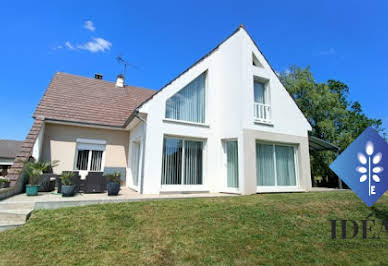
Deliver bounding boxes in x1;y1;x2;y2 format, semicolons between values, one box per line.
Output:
255;141;303;193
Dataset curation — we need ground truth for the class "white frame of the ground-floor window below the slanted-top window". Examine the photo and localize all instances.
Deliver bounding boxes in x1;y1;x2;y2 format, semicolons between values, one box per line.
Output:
160;135;207;192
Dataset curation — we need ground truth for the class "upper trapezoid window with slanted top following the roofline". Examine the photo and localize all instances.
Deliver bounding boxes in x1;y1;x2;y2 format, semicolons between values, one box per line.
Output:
166;73;206;123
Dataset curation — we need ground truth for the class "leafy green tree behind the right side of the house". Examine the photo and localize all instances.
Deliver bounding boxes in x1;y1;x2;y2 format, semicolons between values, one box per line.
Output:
279;66;385;185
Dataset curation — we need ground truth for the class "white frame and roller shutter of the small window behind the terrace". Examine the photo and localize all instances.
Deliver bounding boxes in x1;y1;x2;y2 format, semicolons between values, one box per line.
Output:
73;138;106;176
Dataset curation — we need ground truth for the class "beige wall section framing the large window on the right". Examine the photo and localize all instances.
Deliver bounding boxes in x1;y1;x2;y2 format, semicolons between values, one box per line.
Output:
242;130;311;194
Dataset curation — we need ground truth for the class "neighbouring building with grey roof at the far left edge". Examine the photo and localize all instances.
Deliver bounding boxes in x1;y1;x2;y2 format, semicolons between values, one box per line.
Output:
0;139;23;177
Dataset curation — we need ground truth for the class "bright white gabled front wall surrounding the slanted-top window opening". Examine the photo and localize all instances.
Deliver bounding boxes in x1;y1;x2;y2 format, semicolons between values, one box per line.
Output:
138;29;310;193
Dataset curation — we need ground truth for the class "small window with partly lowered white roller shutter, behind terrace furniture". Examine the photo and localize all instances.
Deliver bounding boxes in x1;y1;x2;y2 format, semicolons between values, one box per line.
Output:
75;139;105;172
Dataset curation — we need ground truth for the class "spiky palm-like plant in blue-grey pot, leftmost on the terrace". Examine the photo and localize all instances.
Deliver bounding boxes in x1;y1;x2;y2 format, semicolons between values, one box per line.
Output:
24;160;58;196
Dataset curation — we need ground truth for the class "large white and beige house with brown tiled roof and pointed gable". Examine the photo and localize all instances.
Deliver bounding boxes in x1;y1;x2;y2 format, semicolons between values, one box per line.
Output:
5;26;311;194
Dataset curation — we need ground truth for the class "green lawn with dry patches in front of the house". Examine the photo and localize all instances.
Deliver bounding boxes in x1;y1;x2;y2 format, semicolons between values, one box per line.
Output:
0;192;388;265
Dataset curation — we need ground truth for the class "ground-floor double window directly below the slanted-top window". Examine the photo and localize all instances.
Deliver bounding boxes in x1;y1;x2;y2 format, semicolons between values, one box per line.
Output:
162;138;203;185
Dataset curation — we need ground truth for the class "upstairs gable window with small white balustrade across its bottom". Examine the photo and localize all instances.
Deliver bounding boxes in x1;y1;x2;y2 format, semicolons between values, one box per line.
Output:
253;79;271;123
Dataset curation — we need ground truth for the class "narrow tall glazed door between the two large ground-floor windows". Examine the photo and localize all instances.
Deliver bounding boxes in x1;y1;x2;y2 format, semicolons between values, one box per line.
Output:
225;140;238;188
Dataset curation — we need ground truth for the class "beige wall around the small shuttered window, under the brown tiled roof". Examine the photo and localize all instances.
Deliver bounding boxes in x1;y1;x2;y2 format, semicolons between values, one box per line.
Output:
42;124;129;176
